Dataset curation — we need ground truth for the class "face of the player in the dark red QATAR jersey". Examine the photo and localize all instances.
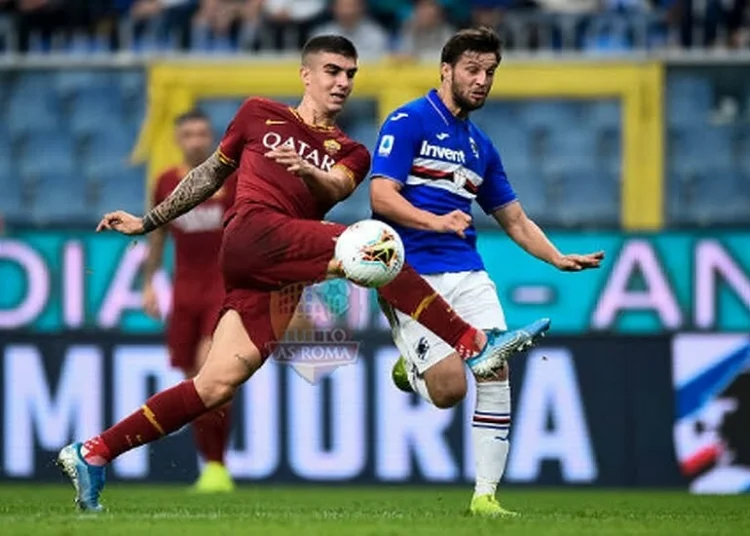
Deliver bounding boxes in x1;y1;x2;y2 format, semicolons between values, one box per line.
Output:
302;52;357;115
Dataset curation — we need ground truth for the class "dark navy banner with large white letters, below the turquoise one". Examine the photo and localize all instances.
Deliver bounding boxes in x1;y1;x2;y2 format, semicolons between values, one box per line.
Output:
0;334;688;487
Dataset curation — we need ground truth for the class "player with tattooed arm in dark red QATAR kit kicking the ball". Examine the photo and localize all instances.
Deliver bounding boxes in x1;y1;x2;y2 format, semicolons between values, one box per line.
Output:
58;35;549;511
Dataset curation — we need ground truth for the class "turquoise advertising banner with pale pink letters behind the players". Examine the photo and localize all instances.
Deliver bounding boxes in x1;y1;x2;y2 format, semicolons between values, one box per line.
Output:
0;230;750;335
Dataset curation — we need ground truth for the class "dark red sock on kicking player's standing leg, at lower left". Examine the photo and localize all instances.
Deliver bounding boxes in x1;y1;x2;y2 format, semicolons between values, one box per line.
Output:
81;380;206;465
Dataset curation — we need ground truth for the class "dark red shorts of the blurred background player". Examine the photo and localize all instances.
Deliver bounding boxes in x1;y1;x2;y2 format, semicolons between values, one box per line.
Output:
167;292;224;370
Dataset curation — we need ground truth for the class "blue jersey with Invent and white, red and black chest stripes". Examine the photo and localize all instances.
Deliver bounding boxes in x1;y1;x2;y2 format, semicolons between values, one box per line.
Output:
372;90;516;274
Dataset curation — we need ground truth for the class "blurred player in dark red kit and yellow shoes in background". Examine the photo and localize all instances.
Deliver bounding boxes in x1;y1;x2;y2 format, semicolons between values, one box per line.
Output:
143;110;236;492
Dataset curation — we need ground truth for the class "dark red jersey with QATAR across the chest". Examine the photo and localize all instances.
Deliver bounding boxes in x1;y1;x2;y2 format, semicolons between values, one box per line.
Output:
219;97;370;220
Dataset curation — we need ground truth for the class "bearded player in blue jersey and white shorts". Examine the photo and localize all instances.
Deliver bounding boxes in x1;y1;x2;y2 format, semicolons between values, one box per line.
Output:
370;28;604;516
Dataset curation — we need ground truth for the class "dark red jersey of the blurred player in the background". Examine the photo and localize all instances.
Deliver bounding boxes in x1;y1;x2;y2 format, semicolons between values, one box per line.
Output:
153;166;236;296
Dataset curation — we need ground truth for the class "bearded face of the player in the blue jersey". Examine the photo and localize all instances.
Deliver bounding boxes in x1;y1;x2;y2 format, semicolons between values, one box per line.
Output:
443;51;498;112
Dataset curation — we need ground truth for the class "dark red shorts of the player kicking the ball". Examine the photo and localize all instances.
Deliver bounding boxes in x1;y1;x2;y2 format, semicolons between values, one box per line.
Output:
221;205;346;359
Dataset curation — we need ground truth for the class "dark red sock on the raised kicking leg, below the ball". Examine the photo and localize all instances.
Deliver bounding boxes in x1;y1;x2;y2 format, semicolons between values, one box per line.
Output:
378;264;482;359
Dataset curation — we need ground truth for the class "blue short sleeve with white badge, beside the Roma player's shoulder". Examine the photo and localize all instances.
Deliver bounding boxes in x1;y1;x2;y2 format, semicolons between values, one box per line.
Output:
372;109;422;184
